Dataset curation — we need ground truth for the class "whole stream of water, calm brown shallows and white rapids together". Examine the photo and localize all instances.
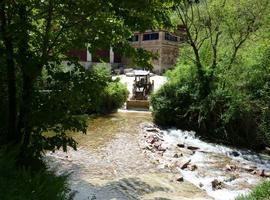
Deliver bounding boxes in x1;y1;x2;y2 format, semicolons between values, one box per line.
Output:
45;112;270;200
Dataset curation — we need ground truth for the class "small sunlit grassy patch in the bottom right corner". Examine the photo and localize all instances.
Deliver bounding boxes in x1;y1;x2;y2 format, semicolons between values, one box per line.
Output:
236;181;270;200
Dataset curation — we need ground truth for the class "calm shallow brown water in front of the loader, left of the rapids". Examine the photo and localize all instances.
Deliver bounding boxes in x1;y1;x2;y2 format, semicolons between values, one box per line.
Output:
45;112;211;200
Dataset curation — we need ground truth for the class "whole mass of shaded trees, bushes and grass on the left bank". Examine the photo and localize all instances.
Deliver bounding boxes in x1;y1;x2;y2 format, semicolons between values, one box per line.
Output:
0;0;173;199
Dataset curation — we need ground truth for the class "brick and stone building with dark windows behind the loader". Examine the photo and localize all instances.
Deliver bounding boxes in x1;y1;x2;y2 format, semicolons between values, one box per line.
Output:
67;27;185;73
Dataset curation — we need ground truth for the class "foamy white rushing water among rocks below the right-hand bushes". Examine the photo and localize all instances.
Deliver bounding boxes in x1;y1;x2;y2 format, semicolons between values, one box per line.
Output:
159;129;270;200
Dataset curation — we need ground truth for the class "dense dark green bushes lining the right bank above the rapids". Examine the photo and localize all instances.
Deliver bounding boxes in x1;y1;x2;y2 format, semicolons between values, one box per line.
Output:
151;56;270;149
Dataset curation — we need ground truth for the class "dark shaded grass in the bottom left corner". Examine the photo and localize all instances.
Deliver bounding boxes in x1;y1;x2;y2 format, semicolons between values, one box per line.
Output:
0;146;73;200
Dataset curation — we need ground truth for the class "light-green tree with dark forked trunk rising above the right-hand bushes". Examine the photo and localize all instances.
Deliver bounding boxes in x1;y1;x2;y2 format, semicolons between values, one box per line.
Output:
176;0;269;98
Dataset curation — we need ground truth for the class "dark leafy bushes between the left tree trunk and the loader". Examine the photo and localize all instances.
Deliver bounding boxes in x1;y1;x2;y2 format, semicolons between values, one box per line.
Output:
24;64;128;157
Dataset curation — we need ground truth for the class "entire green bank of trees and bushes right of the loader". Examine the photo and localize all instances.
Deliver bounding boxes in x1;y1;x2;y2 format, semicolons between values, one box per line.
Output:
151;0;270;149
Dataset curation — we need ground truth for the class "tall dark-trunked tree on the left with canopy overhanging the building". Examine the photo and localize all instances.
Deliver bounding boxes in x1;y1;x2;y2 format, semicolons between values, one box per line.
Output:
0;0;173;159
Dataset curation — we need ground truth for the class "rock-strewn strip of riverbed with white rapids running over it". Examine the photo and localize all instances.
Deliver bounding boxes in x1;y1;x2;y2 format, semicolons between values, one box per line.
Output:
140;123;270;200
